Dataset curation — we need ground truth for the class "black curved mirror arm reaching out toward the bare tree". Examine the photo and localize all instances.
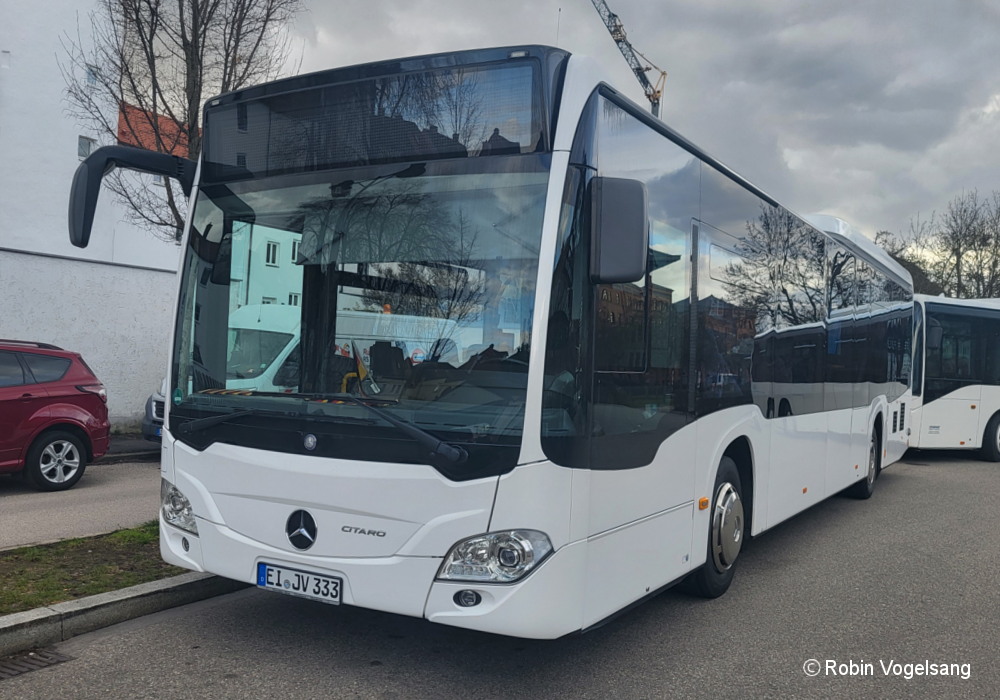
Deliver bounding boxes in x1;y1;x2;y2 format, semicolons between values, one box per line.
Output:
69;146;197;248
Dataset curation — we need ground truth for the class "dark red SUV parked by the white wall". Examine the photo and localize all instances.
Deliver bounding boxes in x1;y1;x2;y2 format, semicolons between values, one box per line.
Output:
0;340;111;491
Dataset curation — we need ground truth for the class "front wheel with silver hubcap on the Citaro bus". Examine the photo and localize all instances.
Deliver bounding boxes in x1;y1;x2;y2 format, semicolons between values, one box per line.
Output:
683;457;746;598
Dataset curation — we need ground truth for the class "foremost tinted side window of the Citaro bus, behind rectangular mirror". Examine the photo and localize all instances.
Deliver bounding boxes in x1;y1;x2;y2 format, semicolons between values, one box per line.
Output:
542;90;700;468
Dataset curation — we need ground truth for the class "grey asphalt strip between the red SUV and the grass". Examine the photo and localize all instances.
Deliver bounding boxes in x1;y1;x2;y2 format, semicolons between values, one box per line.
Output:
0;462;160;552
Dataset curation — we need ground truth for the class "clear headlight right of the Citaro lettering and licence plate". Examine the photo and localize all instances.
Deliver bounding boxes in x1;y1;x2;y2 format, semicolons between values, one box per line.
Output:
437;530;552;583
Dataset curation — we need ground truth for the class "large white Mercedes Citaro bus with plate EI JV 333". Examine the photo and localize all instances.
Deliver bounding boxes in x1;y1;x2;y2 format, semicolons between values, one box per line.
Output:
70;46;910;638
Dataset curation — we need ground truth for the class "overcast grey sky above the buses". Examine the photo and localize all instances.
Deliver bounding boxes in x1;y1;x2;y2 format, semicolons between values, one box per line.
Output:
286;0;1000;236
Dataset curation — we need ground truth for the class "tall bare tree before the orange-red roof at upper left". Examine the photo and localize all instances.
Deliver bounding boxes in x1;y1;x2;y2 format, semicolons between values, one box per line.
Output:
61;0;301;240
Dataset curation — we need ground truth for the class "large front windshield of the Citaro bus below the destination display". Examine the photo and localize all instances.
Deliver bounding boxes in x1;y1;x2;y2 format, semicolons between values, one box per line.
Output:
171;154;550;470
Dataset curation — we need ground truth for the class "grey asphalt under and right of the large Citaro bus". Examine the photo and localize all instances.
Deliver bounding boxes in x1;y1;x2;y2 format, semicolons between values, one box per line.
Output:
0;454;1000;700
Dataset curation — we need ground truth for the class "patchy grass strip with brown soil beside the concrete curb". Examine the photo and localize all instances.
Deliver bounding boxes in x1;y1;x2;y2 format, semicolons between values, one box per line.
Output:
0;520;185;615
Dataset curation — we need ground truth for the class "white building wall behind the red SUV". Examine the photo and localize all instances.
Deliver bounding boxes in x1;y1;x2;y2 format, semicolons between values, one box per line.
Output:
0;0;179;428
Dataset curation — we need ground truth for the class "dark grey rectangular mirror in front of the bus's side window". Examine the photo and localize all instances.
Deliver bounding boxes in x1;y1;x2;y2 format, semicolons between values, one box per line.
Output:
590;177;649;284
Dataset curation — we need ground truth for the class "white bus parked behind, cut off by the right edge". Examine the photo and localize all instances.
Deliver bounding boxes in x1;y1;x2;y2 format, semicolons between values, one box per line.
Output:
907;295;1000;462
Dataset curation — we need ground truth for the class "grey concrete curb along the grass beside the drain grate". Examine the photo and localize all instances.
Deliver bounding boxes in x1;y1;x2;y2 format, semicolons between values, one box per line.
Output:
0;572;250;657
